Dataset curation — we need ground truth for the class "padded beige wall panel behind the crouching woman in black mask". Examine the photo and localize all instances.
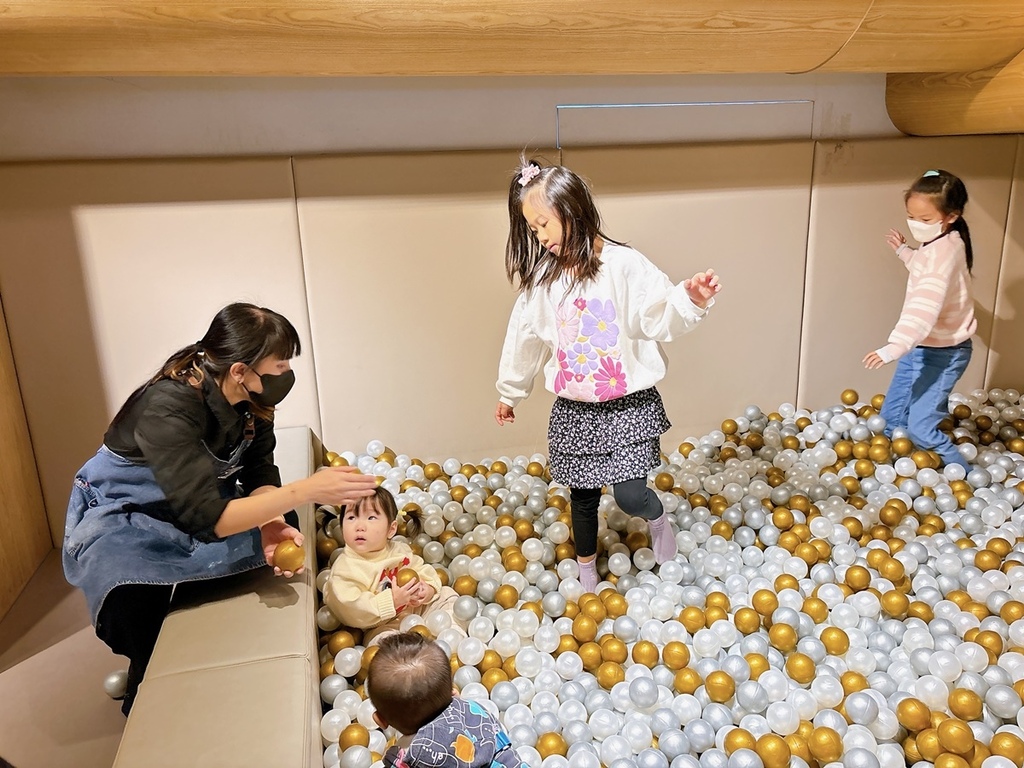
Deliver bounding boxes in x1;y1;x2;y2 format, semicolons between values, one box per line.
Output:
0;159;318;542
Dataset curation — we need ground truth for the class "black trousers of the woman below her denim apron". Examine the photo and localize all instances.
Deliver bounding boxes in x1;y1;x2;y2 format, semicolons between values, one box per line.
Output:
96;584;174;715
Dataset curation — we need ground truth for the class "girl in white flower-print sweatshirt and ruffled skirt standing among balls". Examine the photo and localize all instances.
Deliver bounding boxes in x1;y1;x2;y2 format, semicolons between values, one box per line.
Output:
495;161;721;592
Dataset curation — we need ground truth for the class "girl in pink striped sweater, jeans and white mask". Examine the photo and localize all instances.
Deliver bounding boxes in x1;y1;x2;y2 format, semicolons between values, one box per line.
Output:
864;170;978;471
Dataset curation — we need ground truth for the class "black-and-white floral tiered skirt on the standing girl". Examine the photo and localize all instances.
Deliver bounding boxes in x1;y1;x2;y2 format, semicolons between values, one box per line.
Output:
548;387;672;488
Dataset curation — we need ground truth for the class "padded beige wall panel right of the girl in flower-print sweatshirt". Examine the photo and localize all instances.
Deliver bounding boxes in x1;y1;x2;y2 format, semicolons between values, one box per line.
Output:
562;141;813;451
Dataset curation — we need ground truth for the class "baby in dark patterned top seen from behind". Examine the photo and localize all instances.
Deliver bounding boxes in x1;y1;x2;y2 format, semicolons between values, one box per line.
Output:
367;633;525;768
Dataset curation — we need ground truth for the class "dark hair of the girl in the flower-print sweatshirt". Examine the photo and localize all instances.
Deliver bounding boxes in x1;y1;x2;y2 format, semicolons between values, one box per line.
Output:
505;157;622;291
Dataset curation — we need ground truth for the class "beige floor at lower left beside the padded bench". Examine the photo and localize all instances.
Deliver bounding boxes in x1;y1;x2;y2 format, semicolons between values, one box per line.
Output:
0;550;127;768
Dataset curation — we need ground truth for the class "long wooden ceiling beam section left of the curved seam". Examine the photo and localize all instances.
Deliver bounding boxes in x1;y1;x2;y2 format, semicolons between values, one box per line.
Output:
0;0;871;76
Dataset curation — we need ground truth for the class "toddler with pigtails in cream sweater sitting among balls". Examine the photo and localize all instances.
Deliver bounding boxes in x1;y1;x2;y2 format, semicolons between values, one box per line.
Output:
324;486;458;645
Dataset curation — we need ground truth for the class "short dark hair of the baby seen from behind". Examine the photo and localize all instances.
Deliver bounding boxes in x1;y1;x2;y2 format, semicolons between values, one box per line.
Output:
367;632;453;734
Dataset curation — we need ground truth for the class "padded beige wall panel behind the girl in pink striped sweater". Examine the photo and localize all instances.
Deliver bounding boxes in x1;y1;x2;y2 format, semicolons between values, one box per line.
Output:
800;136;1017;409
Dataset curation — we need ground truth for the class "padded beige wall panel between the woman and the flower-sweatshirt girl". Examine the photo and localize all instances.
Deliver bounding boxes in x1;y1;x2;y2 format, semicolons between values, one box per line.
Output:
295;152;551;461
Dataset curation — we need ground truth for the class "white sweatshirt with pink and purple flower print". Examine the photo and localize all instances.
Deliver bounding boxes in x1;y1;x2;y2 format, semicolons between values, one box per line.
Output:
497;243;714;408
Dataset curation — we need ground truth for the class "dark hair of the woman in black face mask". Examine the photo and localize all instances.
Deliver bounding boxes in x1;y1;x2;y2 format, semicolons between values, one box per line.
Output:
114;303;302;424
